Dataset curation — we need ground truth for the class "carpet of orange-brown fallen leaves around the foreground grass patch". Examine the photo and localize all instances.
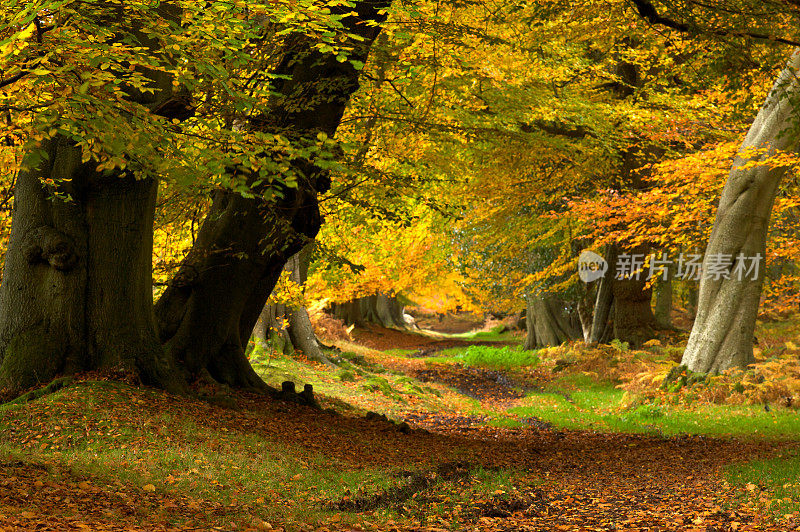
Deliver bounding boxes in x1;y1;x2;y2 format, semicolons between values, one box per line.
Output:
0;326;800;532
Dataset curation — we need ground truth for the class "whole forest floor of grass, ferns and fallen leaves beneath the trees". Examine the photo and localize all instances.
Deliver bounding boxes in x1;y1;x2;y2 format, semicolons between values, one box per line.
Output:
0;321;800;532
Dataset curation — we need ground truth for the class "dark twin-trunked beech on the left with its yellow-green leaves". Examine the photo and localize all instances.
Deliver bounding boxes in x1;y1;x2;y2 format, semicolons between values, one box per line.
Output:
0;2;388;393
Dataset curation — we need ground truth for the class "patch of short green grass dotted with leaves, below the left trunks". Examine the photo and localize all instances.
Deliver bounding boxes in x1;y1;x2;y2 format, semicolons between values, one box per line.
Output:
0;382;446;524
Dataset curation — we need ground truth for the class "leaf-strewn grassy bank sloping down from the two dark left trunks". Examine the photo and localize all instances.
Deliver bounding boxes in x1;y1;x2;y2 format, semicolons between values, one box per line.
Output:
0;376;532;530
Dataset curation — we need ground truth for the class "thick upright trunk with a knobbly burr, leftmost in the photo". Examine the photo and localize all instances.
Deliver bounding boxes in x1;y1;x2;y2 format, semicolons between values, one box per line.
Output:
0;136;181;392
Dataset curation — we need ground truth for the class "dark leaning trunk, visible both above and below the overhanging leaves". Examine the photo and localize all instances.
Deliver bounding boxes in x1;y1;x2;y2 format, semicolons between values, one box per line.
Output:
156;1;389;388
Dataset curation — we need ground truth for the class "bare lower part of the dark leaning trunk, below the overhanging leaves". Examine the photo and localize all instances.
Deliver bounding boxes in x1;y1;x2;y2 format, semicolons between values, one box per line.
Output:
156;191;310;388
